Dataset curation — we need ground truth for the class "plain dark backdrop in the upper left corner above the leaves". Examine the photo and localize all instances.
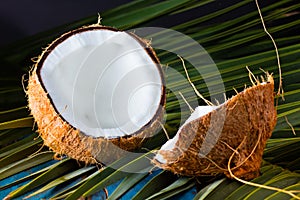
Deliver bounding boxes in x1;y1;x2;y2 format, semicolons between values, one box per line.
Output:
0;0;130;46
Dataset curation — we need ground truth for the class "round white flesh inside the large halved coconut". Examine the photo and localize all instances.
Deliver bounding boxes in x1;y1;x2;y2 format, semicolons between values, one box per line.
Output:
39;29;163;138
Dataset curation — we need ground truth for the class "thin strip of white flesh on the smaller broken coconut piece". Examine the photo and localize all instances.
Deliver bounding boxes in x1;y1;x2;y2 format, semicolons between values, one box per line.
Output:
154;105;220;164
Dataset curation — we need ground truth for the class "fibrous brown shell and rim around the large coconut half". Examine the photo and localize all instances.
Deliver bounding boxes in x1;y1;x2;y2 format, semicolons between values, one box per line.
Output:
27;24;166;164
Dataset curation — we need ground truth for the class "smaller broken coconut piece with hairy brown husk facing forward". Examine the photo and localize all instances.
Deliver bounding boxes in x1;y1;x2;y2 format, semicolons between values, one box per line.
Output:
153;75;276;180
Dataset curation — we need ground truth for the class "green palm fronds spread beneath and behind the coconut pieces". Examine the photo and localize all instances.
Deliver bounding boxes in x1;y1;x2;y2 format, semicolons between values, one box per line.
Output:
0;0;300;199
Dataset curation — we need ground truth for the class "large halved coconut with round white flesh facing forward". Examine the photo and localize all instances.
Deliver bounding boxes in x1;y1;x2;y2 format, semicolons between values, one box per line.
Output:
27;25;165;164
